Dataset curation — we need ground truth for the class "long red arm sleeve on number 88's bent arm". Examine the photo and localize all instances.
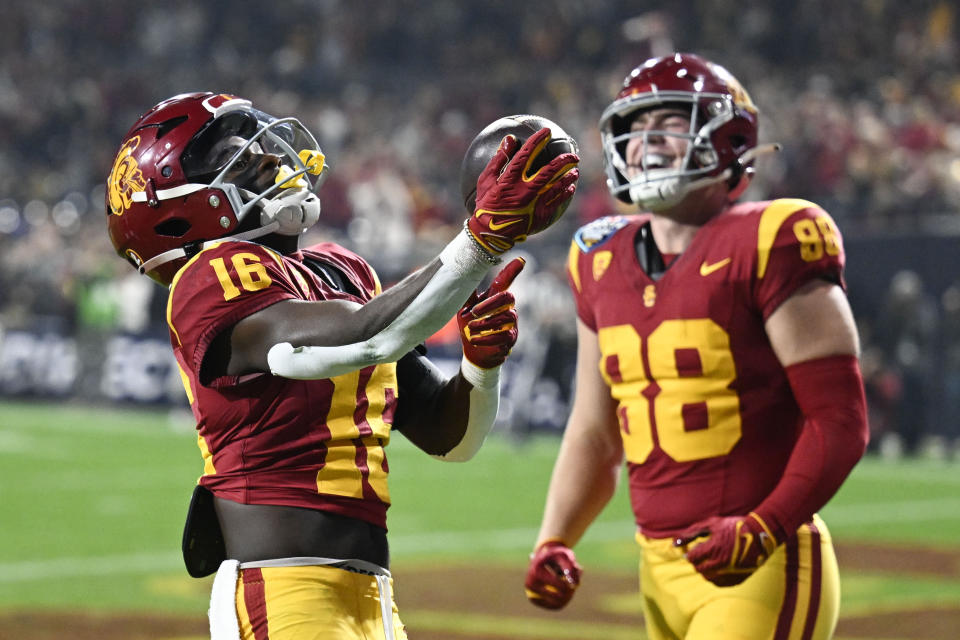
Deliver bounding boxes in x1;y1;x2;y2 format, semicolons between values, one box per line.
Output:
754;355;869;542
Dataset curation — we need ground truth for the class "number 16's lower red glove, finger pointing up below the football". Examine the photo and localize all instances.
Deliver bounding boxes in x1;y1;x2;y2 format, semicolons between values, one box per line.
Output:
457;258;526;369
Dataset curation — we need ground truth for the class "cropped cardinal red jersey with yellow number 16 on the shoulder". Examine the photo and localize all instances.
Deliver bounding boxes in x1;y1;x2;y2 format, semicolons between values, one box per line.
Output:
167;241;397;527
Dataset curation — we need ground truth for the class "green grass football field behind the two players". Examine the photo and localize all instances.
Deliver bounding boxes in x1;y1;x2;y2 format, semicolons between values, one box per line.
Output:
0;402;960;637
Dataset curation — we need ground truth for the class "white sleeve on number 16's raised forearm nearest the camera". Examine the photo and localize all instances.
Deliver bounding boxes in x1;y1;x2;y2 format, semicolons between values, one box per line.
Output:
267;229;499;380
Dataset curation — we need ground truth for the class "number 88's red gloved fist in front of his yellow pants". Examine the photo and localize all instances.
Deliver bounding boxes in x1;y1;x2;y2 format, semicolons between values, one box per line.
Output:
674;511;778;587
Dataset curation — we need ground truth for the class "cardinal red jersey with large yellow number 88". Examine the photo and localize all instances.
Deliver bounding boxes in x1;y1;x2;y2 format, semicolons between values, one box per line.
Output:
568;200;845;537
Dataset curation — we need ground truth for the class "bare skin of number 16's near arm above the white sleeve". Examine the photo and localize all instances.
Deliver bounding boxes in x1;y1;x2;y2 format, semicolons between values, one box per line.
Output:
221;258;440;375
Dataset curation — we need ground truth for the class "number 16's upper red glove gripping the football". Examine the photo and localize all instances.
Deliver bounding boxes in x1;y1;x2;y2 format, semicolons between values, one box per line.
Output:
467;128;580;255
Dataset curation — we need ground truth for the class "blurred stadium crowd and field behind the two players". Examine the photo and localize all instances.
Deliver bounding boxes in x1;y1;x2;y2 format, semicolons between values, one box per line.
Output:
0;0;960;638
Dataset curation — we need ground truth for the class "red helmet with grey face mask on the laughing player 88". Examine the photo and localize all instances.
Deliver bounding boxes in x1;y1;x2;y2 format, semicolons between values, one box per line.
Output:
600;53;758;210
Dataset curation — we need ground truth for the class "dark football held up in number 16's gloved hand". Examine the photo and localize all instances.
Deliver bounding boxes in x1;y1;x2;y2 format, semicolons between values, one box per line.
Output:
460;114;579;214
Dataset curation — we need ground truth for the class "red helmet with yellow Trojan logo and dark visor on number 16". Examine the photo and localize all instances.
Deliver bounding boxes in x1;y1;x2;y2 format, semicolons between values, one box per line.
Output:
106;93;326;286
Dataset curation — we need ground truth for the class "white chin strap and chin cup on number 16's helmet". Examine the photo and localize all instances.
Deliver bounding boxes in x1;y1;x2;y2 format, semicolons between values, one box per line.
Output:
137;189;320;274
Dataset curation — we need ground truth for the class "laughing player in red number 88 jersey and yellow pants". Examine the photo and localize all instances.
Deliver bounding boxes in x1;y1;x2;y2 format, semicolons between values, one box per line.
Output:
525;54;867;640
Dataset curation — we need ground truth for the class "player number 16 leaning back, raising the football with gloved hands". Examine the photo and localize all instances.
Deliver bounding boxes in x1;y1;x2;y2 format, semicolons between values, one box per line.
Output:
106;93;578;640
